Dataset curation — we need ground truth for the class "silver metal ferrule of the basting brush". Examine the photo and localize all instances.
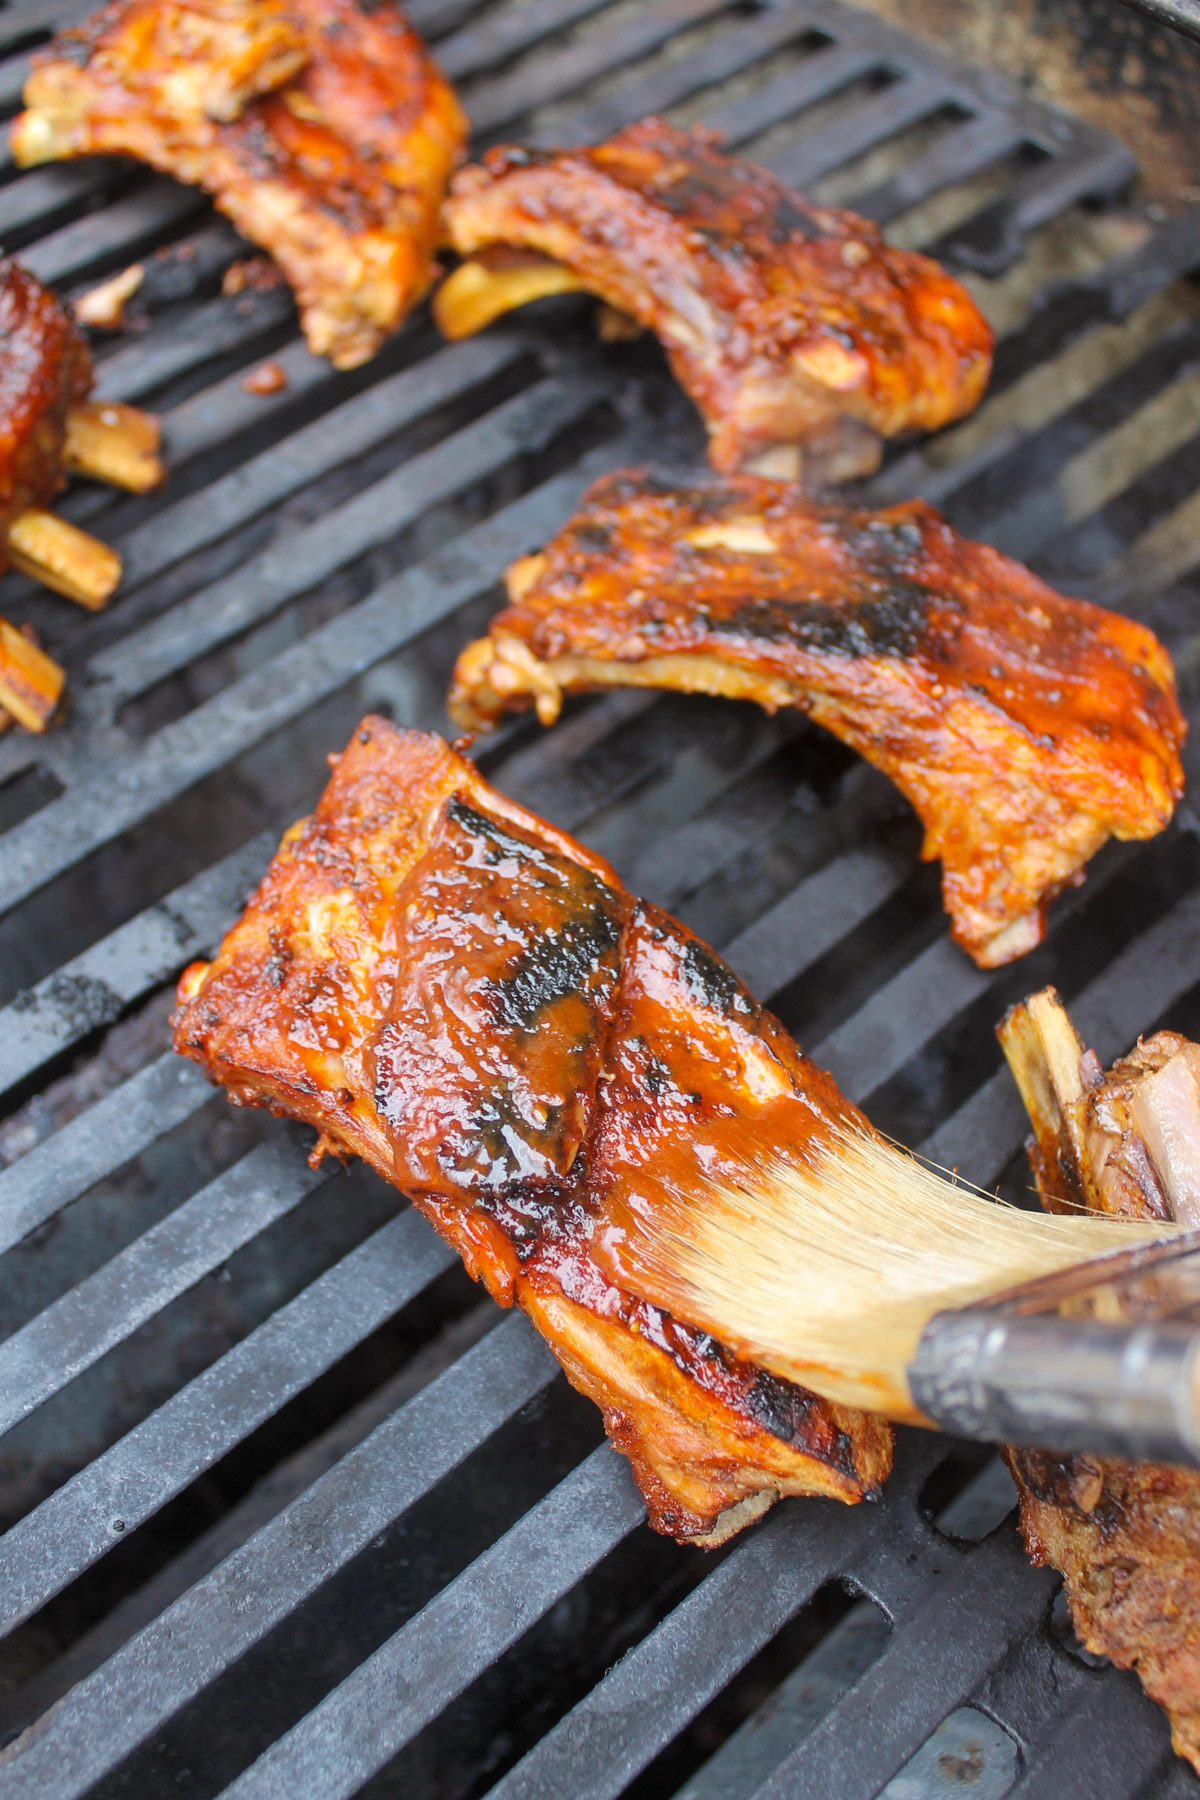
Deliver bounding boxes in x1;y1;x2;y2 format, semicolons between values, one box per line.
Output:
909;1307;1200;1465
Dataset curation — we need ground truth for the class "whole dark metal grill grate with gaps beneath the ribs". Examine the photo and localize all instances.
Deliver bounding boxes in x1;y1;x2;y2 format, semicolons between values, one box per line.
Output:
0;0;1200;1800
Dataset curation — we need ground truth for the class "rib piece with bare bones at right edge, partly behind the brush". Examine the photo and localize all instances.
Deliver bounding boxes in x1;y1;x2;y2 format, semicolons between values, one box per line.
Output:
999;988;1200;1773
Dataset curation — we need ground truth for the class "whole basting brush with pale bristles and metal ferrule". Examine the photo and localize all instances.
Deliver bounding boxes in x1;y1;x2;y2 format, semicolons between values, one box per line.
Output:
604;1121;1200;1463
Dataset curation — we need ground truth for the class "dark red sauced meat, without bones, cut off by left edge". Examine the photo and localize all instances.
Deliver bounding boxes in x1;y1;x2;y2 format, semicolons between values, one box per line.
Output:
0;259;92;547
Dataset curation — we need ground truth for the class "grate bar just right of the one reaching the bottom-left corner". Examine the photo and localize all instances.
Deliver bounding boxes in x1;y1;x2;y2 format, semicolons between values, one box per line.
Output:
225;1444;646;1800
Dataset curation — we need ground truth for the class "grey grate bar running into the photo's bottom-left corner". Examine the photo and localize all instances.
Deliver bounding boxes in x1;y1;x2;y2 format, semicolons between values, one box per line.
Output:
0;1316;558;1800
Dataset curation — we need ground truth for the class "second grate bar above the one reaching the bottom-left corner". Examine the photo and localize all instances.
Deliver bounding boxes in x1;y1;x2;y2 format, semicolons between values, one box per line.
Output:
0;1141;333;1433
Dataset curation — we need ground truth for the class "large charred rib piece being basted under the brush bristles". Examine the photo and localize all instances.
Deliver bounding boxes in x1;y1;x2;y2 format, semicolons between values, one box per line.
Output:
175;718;891;1543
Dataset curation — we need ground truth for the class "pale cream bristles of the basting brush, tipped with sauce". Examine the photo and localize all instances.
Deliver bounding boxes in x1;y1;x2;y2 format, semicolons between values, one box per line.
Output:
611;1125;1171;1420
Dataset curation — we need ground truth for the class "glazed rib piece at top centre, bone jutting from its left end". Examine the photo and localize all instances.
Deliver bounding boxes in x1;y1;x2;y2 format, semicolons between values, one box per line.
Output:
434;119;991;479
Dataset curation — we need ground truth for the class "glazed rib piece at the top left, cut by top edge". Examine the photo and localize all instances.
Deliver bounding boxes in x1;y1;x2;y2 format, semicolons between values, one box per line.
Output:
11;0;466;369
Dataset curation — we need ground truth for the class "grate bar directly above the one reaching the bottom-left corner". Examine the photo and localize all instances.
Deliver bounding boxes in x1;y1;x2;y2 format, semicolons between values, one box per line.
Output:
0;1211;457;1633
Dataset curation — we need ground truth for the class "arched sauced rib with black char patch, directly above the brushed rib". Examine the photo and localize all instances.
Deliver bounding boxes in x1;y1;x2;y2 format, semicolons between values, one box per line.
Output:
450;470;1186;967
